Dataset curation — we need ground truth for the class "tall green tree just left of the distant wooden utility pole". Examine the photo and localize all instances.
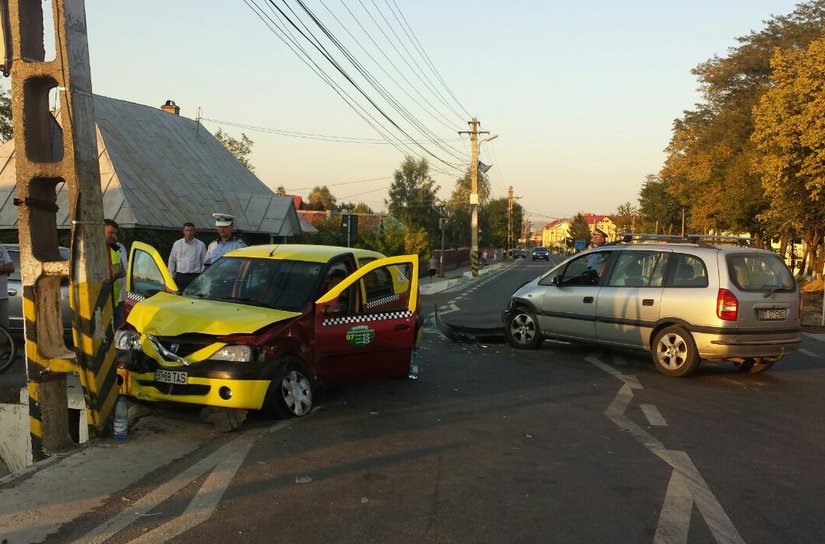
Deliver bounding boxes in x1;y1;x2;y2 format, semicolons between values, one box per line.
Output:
385;156;440;241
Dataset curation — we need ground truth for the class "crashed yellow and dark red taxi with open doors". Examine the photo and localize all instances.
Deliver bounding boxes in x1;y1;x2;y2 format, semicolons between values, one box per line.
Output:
115;242;419;417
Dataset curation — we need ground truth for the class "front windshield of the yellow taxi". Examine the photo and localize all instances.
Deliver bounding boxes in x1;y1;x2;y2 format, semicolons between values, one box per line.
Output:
181;257;321;311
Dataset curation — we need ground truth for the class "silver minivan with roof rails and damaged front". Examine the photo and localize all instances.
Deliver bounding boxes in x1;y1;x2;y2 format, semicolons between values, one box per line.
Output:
502;235;802;376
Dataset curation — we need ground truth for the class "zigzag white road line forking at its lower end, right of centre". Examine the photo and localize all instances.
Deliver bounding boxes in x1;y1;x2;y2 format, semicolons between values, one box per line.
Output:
585;353;745;544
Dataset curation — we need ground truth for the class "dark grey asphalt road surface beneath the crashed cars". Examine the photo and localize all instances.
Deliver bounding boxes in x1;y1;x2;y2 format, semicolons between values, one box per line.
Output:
46;260;825;544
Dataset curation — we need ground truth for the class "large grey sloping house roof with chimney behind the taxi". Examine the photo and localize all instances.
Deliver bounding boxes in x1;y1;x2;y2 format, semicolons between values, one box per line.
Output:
0;95;315;244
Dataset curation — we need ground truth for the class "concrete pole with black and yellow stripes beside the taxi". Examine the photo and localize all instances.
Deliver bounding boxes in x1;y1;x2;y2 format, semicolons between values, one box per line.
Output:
9;0;112;460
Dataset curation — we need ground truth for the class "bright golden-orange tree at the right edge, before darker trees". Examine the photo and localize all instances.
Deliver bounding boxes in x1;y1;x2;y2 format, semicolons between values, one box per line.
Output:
752;38;825;274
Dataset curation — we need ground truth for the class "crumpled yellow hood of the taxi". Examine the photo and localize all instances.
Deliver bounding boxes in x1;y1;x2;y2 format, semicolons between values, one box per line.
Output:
128;293;301;336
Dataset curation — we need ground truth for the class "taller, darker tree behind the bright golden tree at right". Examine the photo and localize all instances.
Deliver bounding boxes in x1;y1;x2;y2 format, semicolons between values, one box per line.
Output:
656;0;825;234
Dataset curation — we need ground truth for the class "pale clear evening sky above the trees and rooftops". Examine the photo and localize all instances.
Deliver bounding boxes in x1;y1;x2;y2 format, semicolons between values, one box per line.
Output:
80;0;796;222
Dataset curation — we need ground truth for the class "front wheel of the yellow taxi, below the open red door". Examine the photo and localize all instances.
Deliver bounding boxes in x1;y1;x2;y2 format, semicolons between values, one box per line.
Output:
265;357;315;418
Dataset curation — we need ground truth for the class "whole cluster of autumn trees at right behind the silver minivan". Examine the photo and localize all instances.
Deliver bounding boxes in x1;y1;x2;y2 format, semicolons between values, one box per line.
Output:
637;0;825;273
